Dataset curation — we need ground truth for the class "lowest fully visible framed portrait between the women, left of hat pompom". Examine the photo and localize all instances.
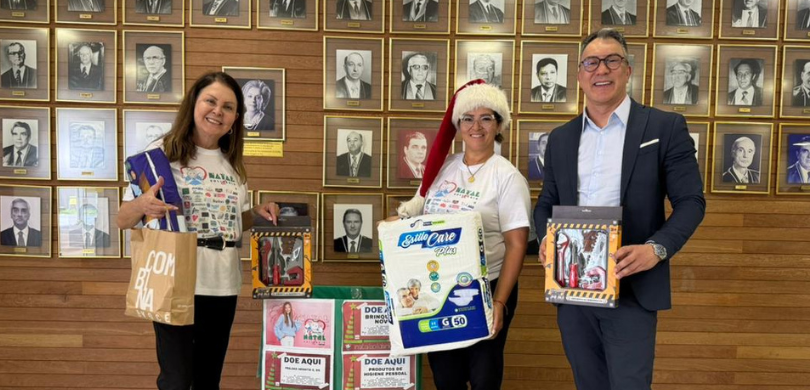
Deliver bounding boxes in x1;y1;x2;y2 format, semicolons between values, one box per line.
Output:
321;193;384;261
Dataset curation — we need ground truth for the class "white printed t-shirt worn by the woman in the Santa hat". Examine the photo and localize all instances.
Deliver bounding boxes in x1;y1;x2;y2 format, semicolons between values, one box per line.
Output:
417;153;531;280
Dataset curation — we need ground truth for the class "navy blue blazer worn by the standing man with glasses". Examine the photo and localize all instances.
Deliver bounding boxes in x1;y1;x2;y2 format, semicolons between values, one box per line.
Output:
534;101;706;310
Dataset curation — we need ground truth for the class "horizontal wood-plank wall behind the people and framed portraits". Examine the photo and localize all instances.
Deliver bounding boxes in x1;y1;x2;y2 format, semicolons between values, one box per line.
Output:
0;0;810;390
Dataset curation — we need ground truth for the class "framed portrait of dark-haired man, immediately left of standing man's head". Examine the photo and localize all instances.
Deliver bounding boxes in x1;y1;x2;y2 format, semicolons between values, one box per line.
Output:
518;41;579;114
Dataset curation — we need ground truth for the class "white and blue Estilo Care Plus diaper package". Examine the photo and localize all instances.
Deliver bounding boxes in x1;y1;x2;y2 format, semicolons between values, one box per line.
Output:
378;211;493;356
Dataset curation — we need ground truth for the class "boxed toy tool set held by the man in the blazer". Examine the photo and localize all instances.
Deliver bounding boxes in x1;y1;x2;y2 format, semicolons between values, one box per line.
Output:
545;206;622;308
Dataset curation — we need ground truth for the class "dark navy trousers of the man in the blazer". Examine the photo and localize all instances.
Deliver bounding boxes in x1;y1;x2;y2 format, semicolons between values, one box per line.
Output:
557;285;658;390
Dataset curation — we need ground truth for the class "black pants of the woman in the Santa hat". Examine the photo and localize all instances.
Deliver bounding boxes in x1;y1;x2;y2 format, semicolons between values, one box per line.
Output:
428;279;518;390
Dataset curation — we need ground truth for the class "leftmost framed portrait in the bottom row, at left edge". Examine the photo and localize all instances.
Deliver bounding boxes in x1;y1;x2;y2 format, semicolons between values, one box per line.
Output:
0;185;52;257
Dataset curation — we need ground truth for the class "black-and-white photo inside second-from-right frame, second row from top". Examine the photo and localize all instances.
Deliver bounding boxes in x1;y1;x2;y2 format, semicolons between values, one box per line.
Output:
728;58;765;106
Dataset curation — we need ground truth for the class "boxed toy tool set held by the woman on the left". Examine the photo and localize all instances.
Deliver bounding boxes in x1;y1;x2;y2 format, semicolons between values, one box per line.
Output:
250;217;312;299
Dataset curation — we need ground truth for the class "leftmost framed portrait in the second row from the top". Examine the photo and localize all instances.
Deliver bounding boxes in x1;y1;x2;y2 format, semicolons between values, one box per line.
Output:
0;27;50;101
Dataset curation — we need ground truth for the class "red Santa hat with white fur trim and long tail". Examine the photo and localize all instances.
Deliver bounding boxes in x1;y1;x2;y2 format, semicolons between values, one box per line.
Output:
397;79;512;218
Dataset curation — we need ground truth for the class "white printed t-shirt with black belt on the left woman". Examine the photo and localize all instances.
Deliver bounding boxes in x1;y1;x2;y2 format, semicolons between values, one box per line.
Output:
124;141;250;296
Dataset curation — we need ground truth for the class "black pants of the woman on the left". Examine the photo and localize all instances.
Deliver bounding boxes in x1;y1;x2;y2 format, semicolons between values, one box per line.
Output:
153;295;236;390
